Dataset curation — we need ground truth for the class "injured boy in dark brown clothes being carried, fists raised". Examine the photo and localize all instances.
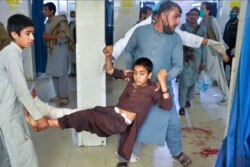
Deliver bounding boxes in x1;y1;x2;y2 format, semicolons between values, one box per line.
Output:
25;46;172;163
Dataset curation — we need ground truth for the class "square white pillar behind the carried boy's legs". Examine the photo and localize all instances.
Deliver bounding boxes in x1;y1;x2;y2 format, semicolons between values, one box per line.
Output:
76;0;106;146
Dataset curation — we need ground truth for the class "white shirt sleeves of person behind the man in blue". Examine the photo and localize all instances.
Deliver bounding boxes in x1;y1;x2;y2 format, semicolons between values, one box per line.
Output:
112;16;203;59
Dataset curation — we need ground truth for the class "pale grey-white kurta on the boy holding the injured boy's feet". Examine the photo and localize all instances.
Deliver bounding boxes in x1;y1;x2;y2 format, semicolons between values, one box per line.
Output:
0;42;42;167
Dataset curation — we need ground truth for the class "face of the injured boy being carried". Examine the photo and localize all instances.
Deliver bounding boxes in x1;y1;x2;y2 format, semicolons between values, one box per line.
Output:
133;65;151;86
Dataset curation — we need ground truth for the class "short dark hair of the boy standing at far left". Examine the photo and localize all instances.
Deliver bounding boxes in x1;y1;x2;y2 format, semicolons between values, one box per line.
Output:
7;14;35;39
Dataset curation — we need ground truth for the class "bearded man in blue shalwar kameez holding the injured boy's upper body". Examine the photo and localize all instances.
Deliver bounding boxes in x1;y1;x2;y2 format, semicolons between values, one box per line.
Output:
124;1;191;166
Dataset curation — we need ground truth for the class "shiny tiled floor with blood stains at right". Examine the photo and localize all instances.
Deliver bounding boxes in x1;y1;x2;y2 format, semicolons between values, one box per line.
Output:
32;70;226;167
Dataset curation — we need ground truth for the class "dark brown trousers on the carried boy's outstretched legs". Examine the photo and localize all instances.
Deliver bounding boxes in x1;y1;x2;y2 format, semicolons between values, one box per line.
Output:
58;106;128;137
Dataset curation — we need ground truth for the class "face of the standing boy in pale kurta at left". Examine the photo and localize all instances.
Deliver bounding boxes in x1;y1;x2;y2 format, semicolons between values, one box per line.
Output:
11;27;34;49
